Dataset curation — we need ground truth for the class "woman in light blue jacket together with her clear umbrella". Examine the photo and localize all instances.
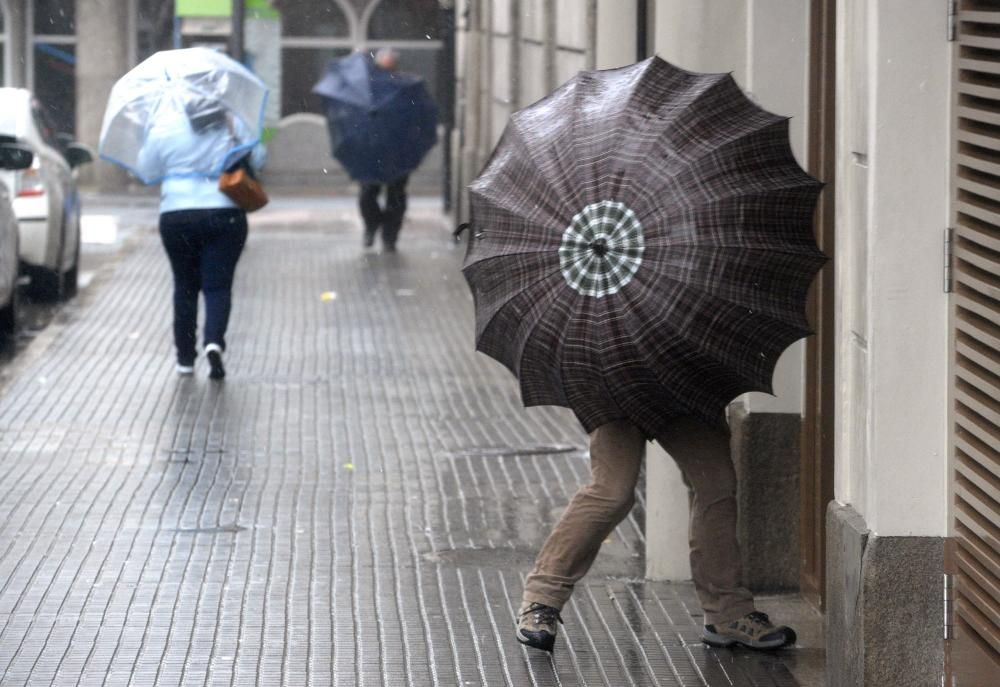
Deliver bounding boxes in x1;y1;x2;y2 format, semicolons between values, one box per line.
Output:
100;48;267;380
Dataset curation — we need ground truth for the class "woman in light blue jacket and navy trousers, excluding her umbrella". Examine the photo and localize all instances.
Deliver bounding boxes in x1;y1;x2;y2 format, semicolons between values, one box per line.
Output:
140;99;265;380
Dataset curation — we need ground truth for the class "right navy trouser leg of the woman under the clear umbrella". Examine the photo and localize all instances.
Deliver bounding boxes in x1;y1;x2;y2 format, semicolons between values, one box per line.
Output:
201;209;247;351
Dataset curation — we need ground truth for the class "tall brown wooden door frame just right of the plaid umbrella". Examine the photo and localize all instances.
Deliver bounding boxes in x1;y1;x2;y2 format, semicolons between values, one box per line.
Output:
799;0;837;609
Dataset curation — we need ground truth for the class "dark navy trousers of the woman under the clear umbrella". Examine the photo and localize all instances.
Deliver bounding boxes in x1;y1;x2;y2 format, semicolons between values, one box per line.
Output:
160;208;247;365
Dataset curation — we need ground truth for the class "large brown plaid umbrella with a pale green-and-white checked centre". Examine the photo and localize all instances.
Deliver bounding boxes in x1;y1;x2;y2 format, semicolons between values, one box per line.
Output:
463;57;826;436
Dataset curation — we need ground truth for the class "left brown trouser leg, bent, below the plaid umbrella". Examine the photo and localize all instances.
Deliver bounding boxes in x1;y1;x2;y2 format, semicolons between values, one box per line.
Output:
523;422;646;609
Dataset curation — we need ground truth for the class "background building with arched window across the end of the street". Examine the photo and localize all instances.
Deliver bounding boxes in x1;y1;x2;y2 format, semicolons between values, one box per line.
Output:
0;0;454;192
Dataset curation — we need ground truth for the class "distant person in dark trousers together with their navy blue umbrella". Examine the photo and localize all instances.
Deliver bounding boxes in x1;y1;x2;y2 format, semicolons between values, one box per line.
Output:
313;48;437;253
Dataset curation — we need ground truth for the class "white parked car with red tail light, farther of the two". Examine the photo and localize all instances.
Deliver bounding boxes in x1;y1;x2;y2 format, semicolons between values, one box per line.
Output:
0;88;93;300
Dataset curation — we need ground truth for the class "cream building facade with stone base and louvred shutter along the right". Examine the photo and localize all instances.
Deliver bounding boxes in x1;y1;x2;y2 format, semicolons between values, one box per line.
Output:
453;0;1000;686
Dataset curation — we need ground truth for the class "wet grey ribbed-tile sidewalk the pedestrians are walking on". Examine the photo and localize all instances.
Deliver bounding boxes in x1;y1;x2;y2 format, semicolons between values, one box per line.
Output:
0;203;808;687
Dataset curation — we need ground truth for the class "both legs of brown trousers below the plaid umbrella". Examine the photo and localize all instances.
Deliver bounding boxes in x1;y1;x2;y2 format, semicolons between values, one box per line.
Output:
524;417;754;624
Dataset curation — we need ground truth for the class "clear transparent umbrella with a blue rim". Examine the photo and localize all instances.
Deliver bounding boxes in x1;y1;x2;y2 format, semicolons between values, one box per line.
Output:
100;48;267;184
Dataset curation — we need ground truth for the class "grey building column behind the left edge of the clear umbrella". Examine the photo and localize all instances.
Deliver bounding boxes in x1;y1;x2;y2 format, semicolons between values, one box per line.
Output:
76;0;132;191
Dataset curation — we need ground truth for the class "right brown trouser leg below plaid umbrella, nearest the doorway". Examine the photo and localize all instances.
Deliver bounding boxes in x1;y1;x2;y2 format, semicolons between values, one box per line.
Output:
656;417;754;624
